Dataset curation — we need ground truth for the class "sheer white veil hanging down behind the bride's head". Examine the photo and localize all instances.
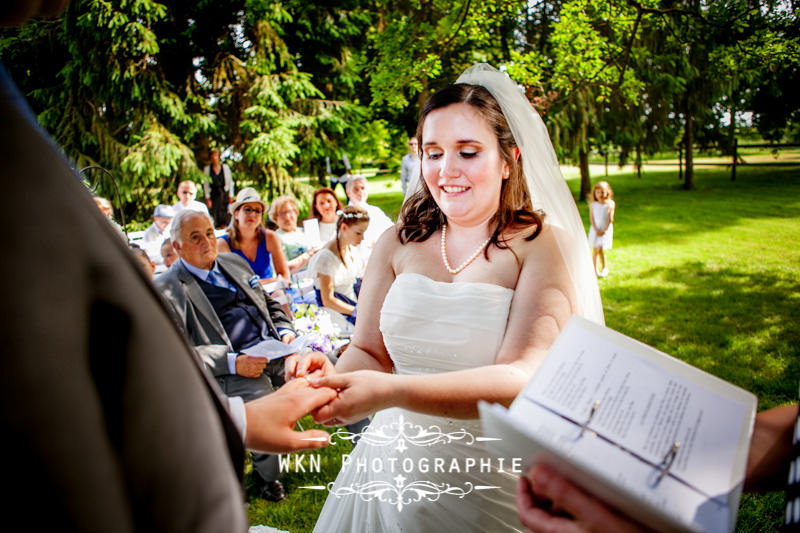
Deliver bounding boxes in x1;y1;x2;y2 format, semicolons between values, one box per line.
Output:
456;63;604;324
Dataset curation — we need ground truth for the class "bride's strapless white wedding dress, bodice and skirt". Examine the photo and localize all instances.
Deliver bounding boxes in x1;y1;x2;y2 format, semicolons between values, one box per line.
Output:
314;274;521;532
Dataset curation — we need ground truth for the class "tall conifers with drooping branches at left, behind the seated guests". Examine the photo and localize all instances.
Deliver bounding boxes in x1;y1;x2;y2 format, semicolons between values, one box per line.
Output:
0;0;362;218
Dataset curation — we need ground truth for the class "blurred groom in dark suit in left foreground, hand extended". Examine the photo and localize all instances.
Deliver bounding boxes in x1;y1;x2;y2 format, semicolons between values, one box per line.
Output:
0;1;335;532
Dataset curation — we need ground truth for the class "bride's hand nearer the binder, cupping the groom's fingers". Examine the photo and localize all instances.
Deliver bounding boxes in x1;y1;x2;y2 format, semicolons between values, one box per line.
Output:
310;370;396;426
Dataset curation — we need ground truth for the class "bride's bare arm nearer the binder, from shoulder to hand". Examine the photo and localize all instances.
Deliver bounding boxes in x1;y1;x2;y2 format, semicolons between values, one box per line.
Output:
315;225;575;421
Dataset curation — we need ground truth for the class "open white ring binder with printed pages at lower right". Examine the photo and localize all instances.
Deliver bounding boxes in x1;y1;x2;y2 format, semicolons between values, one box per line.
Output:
479;316;756;532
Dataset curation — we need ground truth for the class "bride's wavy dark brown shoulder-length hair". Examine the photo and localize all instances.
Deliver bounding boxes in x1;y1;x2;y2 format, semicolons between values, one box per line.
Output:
399;83;544;260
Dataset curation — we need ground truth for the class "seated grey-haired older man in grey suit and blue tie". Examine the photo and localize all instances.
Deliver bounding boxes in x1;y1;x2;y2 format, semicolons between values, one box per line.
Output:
155;210;295;501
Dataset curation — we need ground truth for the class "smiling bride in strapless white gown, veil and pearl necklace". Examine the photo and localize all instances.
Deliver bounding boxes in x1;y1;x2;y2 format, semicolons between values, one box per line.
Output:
287;65;603;531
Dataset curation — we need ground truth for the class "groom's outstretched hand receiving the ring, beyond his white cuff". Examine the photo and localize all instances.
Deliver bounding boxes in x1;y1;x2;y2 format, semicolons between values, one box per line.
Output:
244;379;336;453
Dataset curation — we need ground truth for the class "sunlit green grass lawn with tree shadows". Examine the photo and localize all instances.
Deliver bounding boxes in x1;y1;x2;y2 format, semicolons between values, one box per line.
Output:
249;167;800;533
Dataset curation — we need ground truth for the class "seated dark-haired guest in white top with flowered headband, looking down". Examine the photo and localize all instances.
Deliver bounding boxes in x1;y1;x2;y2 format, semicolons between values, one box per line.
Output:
308;205;369;324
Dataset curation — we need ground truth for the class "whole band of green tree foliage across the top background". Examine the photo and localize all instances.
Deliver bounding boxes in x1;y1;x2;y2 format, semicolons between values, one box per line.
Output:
0;0;800;218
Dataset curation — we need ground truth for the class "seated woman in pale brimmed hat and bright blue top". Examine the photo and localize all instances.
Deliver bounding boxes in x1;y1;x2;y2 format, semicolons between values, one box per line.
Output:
217;187;291;283
